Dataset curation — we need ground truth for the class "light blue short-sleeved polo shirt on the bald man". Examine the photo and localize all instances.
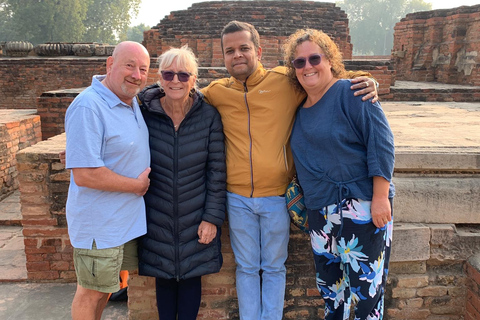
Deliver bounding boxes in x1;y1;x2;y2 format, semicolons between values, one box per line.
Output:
65;76;150;249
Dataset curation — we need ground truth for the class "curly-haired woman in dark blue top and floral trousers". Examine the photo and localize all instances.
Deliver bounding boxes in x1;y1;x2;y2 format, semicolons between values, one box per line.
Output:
285;29;395;320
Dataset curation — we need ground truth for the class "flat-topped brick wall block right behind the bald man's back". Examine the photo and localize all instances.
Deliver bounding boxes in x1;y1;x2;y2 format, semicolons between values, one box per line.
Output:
17;135;75;281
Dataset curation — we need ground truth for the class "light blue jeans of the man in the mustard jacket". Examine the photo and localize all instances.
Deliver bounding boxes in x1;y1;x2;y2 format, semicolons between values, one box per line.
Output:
227;192;290;320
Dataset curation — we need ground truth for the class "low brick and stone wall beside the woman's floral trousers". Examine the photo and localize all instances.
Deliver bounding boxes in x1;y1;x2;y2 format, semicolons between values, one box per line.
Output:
385;224;472;320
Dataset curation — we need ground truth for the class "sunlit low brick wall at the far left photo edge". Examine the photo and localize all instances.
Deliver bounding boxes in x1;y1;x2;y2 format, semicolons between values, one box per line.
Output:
0;110;42;199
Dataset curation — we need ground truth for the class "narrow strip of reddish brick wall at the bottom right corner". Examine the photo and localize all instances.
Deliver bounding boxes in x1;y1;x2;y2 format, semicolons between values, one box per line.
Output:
465;254;480;320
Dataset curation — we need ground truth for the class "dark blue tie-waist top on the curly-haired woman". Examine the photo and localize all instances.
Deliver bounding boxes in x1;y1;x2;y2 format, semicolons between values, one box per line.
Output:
291;80;395;210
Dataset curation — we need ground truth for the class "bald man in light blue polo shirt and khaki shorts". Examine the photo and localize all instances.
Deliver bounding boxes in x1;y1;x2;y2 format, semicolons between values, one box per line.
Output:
65;41;150;320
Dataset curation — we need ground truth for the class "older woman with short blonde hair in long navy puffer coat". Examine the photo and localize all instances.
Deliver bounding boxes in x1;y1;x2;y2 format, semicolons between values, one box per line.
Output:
139;46;226;320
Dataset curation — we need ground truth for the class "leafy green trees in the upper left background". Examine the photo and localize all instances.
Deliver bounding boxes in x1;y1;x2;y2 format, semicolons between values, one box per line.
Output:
0;0;141;44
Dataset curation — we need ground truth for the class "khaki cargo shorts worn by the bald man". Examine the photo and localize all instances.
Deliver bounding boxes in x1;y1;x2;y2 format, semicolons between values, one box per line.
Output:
73;239;138;293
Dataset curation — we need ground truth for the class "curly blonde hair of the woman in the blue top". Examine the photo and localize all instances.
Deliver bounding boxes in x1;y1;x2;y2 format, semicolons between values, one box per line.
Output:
283;29;345;92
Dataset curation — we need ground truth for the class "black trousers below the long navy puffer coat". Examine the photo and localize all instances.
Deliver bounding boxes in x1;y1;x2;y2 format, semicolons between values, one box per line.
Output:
155;277;202;320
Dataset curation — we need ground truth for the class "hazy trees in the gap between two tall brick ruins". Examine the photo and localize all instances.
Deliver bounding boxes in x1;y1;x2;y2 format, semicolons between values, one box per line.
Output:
337;0;432;55
